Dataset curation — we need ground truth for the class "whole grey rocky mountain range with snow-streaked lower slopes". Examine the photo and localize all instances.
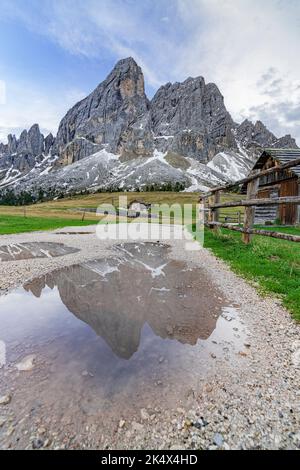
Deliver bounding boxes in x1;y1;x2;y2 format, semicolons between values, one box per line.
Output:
0;58;297;199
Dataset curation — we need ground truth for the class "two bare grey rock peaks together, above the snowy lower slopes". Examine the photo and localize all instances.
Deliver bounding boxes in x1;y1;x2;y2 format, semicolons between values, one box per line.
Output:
56;58;240;164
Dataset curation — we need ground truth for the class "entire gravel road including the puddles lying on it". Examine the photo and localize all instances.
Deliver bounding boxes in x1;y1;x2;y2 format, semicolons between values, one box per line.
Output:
0;227;300;449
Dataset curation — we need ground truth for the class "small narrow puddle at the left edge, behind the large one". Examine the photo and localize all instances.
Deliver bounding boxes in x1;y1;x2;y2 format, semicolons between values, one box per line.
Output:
0;242;80;261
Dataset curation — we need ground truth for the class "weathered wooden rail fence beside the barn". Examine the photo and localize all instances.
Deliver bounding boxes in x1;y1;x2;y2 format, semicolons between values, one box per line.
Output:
200;158;300;244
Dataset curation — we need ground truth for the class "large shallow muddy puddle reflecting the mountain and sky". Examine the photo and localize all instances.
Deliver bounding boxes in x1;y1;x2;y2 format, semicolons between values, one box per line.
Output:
0;243;244;446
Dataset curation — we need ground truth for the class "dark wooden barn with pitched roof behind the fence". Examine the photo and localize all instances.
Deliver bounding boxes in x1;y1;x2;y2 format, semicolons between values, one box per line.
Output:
253;148;300;225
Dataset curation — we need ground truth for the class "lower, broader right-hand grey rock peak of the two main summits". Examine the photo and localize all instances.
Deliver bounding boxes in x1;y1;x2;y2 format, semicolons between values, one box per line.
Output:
151;77;236;162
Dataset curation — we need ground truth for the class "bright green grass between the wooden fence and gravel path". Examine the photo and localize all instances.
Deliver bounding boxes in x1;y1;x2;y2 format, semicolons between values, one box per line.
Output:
200;227;300;321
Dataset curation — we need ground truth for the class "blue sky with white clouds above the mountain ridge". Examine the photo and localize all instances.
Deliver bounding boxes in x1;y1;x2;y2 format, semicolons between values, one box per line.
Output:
0;0;300;145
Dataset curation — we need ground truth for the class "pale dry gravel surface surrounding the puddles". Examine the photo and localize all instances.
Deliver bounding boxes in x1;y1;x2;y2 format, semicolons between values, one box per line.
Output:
0;227;300;449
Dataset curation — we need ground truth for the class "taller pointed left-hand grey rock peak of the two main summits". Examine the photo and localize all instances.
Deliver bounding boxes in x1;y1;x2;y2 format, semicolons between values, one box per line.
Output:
56;58;153;164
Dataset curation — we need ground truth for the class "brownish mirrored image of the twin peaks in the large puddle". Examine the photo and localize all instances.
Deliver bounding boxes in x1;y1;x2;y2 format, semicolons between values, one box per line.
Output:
24;243;222;359
